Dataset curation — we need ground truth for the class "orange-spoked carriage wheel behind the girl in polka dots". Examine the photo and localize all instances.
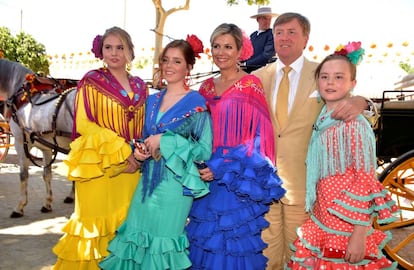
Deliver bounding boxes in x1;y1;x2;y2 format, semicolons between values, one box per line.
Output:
374;150;414;269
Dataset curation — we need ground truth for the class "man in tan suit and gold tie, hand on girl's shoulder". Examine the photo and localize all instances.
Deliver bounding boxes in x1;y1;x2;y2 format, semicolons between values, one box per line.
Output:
253;13;368;270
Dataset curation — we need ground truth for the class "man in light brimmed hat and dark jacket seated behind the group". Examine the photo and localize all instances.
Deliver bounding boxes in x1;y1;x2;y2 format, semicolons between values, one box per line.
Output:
244;7;277;73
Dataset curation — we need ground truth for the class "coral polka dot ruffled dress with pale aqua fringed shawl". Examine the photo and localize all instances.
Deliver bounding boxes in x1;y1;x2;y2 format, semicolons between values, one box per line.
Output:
287;110;398;270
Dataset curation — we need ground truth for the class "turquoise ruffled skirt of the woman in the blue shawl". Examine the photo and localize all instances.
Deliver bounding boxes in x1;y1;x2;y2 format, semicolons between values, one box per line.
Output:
100;170;197;270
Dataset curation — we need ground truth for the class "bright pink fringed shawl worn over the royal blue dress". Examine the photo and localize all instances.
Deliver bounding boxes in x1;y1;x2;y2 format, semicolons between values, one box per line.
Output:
200;75;275;163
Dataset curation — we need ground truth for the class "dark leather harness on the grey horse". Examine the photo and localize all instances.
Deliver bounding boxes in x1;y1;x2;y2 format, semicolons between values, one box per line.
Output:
7;74;78;167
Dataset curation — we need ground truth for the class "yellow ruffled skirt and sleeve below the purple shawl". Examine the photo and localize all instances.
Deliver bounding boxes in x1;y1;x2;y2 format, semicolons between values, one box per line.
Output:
53;127;139;270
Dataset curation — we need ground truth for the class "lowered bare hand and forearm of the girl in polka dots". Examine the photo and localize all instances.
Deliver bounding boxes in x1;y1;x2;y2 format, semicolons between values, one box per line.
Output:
344;225;367;263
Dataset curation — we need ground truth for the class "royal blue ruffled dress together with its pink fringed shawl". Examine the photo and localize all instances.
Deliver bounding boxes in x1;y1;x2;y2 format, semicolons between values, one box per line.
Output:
186;75;285;270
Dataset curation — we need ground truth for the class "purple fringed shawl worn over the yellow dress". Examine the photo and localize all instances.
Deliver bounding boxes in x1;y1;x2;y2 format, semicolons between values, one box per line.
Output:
72;68;148;141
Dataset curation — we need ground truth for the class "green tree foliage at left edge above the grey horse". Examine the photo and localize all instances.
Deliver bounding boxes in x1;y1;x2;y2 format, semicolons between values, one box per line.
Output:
0;27;49;75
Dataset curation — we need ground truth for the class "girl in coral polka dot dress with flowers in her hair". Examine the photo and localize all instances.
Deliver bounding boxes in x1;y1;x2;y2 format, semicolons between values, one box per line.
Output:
287;42;398;270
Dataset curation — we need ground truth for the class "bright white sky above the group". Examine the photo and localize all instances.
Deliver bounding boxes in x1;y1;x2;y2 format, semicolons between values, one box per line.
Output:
0;0;414;96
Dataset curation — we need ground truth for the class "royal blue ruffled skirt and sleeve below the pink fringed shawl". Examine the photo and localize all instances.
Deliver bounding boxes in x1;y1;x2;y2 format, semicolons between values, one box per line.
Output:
187;143;285;270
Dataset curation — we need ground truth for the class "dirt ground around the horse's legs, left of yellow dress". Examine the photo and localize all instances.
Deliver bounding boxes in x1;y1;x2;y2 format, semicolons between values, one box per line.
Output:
0;148;73;270
